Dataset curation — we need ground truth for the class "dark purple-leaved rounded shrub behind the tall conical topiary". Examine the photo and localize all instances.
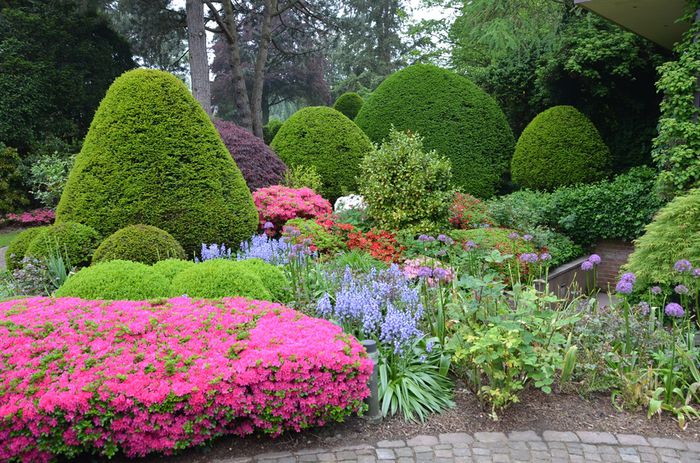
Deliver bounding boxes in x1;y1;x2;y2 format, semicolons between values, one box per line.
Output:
214;120;287;191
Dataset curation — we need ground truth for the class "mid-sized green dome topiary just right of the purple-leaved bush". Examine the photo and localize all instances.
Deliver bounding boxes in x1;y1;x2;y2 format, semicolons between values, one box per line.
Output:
271;106;372;201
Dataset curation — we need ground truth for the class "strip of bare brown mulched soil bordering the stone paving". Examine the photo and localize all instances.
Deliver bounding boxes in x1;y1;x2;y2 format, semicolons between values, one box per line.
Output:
101;382;700;463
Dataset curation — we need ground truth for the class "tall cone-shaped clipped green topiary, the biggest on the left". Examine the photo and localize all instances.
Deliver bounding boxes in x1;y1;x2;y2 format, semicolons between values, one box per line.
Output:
56;69;258;254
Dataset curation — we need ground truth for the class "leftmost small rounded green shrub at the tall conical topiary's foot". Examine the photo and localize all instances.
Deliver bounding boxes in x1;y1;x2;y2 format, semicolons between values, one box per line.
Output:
25;222;100;267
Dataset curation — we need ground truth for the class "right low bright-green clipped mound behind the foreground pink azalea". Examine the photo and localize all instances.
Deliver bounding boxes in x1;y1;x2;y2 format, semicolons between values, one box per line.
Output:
171;259;272;300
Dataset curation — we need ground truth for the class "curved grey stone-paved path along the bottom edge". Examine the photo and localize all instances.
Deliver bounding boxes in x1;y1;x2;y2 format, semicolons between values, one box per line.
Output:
216;431;700;463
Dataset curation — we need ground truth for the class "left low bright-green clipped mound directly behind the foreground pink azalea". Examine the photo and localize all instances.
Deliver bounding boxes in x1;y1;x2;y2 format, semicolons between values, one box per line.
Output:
55;260;170;301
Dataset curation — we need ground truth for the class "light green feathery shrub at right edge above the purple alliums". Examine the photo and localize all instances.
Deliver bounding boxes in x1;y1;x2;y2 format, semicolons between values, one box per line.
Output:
626;189;700;287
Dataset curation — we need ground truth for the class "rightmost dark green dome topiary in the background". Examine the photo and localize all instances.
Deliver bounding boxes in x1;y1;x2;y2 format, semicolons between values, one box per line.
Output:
511;106;611;190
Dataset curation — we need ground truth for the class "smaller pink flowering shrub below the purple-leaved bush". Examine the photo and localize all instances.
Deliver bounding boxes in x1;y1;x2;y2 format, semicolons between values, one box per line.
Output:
253;185;333;235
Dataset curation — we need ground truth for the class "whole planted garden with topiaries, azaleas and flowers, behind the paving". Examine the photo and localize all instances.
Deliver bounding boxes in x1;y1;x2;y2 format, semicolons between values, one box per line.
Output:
0;1;700;462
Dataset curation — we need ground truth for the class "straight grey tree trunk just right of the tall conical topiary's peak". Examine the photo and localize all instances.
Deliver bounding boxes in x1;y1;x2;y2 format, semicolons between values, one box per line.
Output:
185;0;211;116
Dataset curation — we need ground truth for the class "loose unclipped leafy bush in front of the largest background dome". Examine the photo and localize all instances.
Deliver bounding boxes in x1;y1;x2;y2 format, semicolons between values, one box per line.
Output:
358;130;453;231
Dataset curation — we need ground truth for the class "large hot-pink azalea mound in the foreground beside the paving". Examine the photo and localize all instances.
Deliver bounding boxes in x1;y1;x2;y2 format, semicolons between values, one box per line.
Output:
0;297;372;462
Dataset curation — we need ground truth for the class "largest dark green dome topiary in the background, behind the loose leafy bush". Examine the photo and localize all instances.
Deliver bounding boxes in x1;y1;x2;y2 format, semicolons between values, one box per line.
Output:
355;64;515;197
